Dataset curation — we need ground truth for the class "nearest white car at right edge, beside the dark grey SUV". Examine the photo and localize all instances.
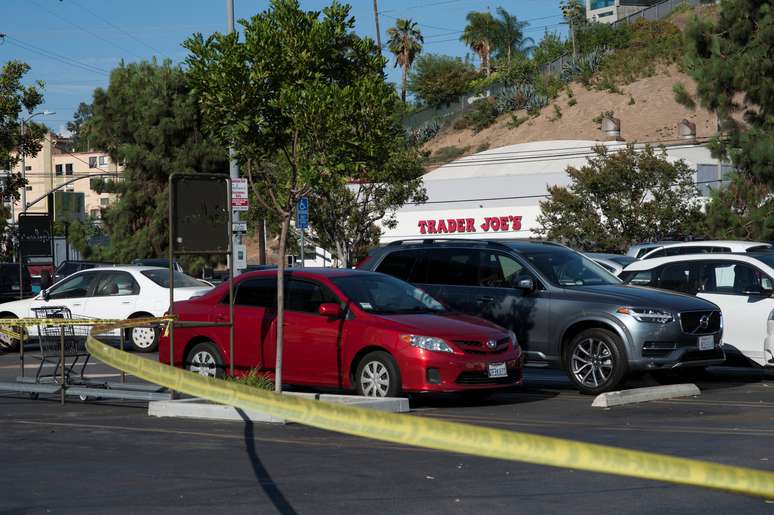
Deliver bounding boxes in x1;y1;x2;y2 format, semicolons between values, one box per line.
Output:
619;252;774;366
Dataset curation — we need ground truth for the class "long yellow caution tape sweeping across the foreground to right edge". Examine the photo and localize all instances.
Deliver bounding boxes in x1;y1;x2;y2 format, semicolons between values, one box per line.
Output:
86;336;774;499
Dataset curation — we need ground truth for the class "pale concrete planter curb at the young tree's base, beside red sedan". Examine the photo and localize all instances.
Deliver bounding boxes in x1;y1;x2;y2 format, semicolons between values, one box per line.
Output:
148;392;410;424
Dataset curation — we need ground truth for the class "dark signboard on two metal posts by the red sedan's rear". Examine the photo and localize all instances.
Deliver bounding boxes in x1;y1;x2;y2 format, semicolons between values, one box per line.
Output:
169;173;234;377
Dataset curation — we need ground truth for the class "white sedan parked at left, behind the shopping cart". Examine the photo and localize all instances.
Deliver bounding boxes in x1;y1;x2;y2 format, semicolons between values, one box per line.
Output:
0;266;211;352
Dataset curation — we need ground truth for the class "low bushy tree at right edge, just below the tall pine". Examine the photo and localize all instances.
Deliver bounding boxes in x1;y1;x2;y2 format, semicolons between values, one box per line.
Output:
705;173;774;241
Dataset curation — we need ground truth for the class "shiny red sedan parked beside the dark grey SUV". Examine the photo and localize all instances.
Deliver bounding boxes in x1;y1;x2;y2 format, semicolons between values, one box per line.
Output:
159;269;522;397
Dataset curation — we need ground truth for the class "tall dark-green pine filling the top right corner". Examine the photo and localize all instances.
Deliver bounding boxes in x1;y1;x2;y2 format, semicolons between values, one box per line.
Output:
685;0;774;187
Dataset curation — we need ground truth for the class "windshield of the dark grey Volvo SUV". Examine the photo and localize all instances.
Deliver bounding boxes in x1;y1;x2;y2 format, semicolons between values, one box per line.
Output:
520;247;621;287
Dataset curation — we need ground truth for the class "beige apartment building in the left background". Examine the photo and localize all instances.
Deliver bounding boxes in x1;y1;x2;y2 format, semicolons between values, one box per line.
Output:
13;133;124;220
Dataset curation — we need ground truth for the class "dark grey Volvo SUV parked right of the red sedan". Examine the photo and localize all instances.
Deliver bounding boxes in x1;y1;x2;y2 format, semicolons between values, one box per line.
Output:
359;240;725;393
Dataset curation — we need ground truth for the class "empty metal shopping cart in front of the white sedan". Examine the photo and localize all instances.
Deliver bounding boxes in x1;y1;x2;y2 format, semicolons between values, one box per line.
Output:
32;306;89;385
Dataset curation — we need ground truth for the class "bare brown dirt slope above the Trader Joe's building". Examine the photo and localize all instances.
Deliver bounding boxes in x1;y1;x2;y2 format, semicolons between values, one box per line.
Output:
424;66;715;159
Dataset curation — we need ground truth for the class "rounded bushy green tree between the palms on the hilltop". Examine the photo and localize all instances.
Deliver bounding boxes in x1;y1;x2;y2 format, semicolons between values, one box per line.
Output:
409;54;476;107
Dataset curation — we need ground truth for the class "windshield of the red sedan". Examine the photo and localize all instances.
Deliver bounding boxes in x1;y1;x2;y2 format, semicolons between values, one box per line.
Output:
332;274;446;315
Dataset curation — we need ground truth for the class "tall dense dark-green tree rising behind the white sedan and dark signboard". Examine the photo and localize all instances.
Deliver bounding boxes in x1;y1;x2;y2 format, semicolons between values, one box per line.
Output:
89;61;227;262
